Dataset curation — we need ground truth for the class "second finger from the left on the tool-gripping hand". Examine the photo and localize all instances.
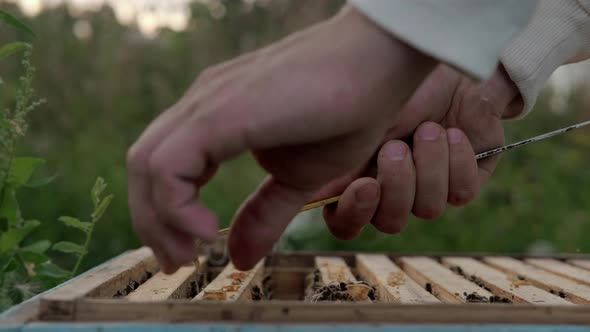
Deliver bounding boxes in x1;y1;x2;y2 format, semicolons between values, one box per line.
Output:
373;141;416;234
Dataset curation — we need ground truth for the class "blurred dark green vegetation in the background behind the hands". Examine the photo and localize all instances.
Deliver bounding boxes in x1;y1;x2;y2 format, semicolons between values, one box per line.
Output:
0;0;590;269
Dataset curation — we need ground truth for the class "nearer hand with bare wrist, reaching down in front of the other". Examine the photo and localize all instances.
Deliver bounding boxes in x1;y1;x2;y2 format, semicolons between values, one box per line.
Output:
128;9;436;273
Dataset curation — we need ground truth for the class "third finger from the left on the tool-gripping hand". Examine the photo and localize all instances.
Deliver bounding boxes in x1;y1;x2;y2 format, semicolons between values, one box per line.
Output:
413;122;449;220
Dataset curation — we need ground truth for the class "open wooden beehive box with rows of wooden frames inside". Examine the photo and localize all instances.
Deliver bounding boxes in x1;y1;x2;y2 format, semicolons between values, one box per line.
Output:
4;248;590;325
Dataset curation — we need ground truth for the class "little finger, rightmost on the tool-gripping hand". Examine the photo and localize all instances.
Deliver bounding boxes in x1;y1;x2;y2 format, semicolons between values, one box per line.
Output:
447;128;479;206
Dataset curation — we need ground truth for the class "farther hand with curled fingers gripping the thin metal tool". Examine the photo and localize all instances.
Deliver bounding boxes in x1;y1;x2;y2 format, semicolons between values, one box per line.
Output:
313;65;522;240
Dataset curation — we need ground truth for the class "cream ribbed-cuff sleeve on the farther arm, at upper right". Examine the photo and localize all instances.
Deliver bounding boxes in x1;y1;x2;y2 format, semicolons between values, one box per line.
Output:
501;0;590;118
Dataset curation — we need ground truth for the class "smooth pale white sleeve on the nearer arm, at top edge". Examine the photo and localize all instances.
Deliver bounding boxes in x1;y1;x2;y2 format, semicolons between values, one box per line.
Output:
348;0;537;80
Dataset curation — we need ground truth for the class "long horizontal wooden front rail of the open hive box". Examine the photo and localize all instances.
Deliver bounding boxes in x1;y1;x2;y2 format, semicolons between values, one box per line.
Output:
76;300;590;325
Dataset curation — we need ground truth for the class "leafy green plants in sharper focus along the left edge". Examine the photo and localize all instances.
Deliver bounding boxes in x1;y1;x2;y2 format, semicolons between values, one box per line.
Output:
0;11;113;311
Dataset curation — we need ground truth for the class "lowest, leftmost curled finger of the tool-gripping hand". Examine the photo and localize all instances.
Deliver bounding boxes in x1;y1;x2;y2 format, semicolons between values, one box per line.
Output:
324;178;380;240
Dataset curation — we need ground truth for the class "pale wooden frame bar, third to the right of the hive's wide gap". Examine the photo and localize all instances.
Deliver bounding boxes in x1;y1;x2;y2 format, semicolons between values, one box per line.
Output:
400;257;493;303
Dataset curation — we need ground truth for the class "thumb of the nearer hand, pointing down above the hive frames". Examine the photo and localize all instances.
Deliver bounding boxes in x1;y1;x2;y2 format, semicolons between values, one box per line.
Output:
228;177;314;270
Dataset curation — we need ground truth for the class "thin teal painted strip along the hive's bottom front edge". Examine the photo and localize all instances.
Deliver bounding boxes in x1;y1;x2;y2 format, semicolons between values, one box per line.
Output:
9;323;590;332
